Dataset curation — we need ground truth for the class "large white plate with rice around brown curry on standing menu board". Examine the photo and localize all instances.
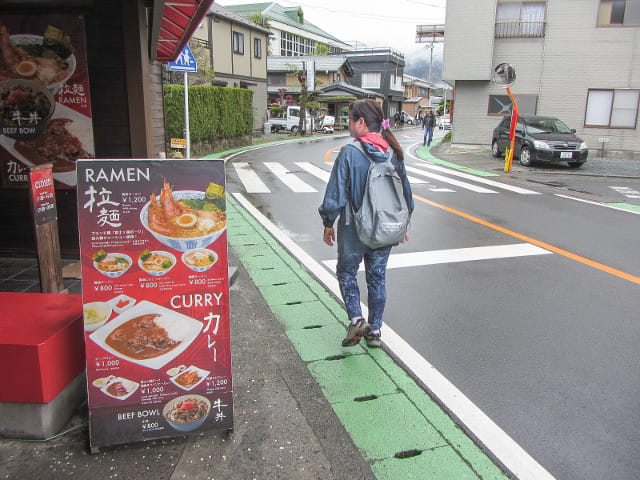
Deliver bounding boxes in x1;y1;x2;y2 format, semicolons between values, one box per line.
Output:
89;300;204;370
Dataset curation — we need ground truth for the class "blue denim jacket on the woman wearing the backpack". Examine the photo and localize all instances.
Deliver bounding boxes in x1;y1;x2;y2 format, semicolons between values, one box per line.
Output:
318;142;414;227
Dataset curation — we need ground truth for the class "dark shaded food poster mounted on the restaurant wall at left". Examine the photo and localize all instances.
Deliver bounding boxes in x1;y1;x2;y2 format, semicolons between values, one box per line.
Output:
0;14;95;188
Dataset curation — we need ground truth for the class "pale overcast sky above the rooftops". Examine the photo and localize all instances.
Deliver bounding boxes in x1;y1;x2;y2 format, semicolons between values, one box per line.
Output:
215;0;446;54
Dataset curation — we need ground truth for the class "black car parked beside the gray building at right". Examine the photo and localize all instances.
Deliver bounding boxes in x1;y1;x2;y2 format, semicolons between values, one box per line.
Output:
491;115;589;168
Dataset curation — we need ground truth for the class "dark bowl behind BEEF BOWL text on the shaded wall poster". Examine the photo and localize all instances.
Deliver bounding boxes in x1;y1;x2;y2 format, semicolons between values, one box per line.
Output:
0;80;55;140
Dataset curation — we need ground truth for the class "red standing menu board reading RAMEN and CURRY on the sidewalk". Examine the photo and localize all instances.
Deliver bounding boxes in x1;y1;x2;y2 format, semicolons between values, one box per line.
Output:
77;160;233;448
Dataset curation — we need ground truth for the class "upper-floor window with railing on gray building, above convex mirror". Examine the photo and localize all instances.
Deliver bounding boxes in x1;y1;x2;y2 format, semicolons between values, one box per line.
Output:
496;2;547;38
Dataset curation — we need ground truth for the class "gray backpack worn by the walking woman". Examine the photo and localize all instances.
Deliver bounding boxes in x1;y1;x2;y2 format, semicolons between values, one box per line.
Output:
352;142;411;248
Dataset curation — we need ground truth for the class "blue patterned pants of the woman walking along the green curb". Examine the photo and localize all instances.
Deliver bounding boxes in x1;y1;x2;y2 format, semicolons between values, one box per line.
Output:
336;223;391;330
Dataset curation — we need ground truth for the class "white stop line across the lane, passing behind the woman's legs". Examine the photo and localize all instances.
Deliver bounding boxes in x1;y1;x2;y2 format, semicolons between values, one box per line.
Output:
322;243;552;272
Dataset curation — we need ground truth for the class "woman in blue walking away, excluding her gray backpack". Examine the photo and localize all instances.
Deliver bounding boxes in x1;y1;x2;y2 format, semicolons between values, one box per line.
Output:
318;99;414;348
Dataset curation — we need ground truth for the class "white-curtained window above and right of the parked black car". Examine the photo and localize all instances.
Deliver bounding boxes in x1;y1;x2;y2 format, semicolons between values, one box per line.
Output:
584;89;640;128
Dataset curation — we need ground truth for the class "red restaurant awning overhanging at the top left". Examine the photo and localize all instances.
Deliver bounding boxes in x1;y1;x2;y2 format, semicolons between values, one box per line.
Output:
151;0;214;62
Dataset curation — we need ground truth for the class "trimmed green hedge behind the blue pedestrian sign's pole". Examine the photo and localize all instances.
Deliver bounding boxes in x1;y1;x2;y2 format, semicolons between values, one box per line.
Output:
164;85;253;143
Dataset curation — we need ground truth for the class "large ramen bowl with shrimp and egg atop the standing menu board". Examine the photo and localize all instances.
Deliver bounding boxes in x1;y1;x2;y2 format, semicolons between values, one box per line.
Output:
140;182;227;252
